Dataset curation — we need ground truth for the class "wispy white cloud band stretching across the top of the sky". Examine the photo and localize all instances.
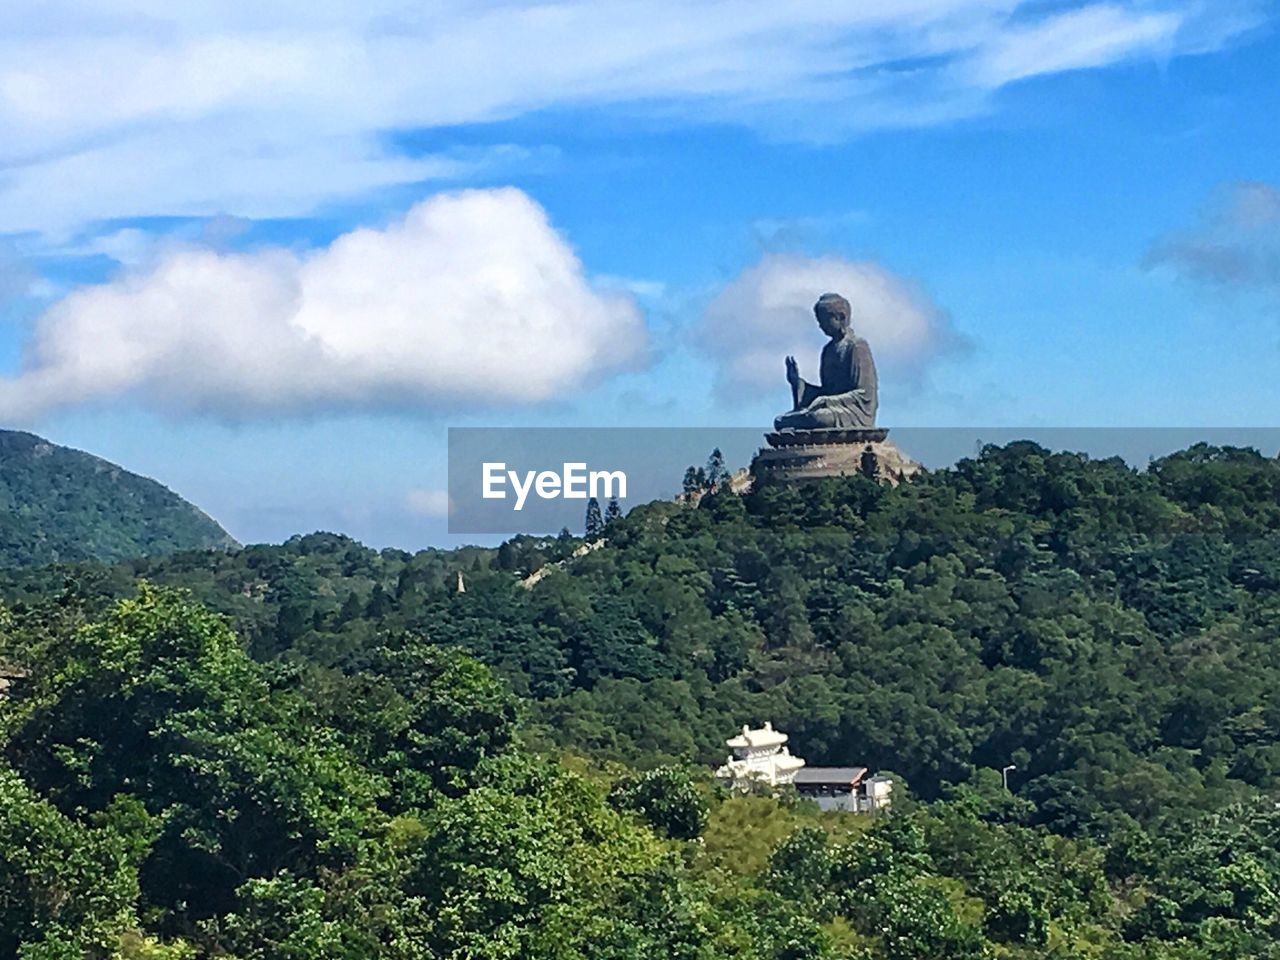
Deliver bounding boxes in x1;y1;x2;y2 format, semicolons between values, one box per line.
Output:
0;0;1263;234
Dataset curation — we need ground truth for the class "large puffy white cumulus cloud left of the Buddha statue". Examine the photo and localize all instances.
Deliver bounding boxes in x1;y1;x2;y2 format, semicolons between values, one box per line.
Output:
0;188;646;420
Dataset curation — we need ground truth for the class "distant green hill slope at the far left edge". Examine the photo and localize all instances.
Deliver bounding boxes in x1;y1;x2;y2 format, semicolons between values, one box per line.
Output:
0;430;237;567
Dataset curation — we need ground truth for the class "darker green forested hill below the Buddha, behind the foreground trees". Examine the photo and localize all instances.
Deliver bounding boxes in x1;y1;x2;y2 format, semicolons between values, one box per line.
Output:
10;443;1280;833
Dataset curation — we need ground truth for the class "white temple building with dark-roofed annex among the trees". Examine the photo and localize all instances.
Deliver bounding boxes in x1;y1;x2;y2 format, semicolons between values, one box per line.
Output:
716;721;893;814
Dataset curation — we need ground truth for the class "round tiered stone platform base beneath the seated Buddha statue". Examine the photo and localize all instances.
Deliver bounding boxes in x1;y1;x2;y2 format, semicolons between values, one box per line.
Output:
751;429;922;484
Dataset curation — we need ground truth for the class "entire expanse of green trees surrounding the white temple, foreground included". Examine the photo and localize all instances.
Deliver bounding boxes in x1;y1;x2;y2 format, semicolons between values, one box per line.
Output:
0;444;1280;960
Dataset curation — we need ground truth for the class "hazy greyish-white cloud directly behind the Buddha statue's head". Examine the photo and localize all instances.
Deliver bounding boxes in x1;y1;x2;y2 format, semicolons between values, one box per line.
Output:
698;253;966;398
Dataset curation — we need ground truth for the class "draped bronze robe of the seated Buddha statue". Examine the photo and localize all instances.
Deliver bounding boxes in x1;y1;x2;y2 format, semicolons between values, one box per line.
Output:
773;335;879;430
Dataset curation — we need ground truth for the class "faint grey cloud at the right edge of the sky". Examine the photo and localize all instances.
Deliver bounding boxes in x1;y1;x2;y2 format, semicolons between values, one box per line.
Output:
1144;182;1280;289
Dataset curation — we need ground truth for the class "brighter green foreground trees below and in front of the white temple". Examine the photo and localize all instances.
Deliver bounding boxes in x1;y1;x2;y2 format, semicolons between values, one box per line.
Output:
0;588;1280;960
